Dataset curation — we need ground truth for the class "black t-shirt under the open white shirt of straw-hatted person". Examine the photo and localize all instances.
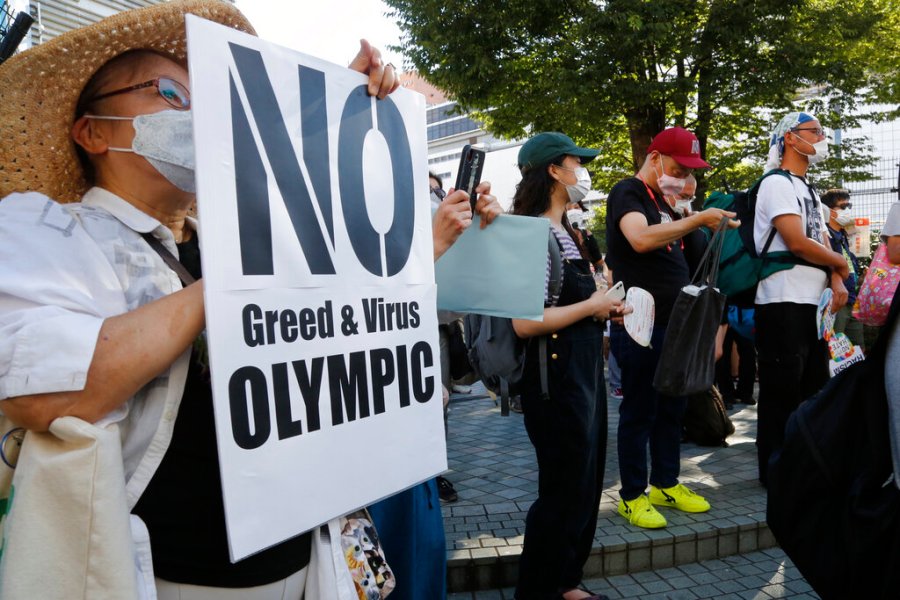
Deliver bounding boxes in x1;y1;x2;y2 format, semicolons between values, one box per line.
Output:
134;235;310;588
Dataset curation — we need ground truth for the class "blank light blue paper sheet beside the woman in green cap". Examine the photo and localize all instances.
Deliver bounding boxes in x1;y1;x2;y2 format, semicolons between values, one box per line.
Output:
434;215;551;321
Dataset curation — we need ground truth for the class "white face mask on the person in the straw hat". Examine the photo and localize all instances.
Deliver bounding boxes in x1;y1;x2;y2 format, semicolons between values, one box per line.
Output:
85;110;197;194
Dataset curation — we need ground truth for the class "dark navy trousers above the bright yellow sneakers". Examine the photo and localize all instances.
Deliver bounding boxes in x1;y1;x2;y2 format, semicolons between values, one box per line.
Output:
610;325;687;500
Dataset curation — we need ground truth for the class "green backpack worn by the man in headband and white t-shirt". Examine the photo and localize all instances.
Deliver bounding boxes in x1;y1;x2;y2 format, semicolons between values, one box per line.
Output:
703;169;818;307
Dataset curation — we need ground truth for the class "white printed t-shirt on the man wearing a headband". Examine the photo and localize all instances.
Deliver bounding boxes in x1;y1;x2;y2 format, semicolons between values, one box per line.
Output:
753;175;828;305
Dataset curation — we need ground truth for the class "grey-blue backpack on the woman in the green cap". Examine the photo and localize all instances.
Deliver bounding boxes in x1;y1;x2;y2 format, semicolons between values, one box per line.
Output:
464;232;562;417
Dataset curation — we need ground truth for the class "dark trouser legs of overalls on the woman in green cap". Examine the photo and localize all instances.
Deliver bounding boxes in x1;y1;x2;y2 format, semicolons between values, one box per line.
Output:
515;320;607;600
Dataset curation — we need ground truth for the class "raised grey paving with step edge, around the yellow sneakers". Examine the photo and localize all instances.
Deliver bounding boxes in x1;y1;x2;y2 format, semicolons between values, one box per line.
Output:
443;384;788;592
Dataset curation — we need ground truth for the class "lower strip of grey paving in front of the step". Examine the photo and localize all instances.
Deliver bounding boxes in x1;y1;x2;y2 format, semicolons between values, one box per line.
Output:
447;548;819;600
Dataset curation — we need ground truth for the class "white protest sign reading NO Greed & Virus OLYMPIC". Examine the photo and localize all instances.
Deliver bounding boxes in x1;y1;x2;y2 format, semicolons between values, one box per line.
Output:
187;16;447;561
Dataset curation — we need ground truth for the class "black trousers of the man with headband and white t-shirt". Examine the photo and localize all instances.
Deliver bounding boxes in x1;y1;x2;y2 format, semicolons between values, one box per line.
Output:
756;302;828;485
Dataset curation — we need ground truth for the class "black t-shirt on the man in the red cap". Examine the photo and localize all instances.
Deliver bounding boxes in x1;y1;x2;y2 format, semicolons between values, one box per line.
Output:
606;177;702;325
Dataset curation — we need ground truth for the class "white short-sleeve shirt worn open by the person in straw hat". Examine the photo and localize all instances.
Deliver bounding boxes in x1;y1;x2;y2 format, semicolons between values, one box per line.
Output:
0;188;190;508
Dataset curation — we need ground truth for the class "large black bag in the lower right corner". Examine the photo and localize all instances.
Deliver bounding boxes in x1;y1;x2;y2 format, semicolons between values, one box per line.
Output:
766;284;900;600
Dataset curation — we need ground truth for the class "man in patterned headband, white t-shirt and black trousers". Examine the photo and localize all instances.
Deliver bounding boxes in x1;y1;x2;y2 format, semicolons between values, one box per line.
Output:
753;112;849;485
